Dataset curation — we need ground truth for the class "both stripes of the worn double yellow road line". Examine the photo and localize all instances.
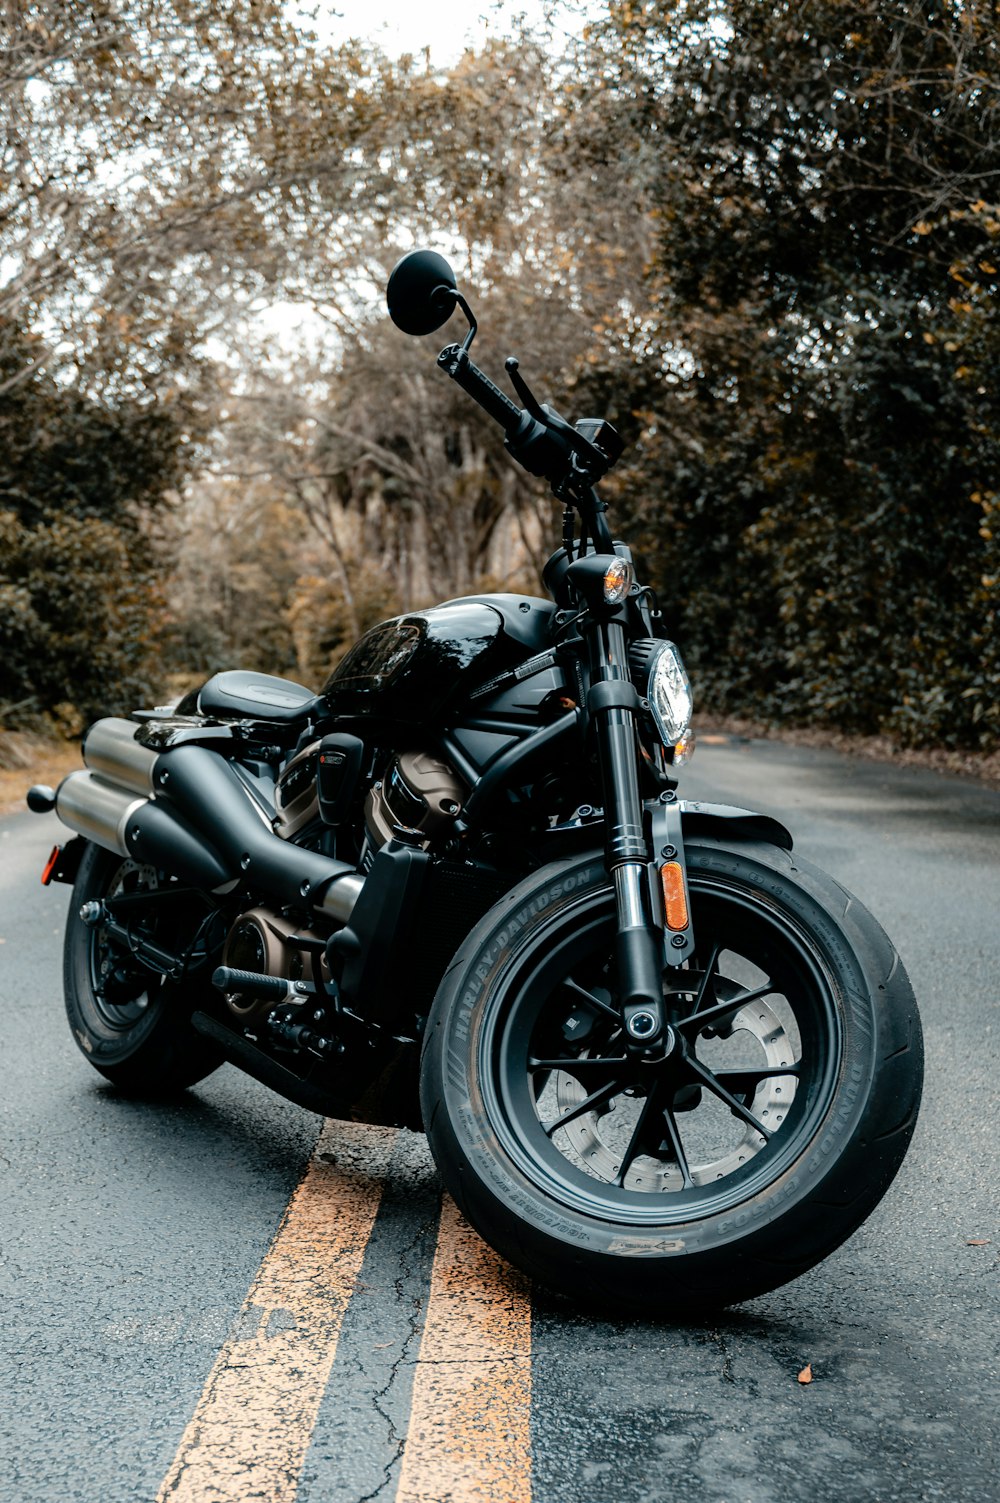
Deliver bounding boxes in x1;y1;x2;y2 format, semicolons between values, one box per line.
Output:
156;1121;531;1503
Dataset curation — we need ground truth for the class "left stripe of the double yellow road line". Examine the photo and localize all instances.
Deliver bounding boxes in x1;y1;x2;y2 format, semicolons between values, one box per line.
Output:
156;1121;393;1503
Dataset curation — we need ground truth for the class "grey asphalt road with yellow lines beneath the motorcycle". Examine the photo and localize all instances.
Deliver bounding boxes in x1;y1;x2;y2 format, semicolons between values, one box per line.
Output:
0;742;1000;1503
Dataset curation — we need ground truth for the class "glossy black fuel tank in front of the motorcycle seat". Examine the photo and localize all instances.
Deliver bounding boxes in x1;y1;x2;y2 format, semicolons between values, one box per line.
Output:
323;595;555;726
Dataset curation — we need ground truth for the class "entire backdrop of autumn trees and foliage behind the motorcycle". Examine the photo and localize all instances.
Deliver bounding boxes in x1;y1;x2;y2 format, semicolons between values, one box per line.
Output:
0;0;1000;745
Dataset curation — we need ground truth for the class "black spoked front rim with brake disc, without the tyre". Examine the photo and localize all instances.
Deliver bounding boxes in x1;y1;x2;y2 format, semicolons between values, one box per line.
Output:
480;882;841;1226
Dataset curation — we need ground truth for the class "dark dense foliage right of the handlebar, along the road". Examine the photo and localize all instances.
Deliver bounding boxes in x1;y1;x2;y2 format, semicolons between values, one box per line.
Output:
574;0;1000;745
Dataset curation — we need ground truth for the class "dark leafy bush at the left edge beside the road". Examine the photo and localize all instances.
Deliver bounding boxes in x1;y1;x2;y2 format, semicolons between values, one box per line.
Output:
0;320;192;726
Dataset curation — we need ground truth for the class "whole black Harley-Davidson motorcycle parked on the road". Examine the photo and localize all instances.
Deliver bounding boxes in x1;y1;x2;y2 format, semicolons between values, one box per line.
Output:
29;251;922;1314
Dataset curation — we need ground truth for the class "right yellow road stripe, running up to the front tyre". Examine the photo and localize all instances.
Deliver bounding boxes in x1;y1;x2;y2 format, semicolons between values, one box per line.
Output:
395;1196;531;1503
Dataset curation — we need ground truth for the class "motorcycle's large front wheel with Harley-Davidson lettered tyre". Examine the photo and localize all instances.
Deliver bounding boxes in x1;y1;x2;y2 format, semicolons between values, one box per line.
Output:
421;837;923;1315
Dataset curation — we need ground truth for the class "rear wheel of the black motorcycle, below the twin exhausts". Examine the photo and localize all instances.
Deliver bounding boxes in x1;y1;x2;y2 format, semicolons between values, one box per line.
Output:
63;845;223;1096
